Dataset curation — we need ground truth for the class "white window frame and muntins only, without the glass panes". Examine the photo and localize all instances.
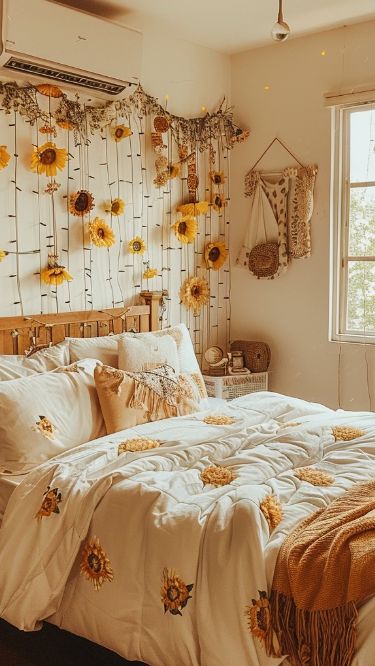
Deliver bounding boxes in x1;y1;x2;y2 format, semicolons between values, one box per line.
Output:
329;100;375;344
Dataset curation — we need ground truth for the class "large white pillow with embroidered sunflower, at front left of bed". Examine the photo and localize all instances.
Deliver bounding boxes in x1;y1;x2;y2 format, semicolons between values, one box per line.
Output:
0;359;106;473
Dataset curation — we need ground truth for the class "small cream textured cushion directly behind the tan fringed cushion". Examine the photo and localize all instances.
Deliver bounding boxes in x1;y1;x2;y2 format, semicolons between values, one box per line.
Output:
118;333;180;375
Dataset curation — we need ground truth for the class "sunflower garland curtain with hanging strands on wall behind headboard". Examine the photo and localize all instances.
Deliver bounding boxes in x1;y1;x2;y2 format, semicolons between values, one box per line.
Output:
0;81;249;366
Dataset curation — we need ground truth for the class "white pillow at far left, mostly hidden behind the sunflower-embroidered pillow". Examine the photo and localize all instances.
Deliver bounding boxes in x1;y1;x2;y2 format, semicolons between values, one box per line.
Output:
0;341;70;381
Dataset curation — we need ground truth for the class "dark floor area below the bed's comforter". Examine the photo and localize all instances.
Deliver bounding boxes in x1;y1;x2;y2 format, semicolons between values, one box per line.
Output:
0;620;146;666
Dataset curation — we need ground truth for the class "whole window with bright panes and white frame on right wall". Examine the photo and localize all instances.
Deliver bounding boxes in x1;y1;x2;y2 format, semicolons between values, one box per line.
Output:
331;103;375;344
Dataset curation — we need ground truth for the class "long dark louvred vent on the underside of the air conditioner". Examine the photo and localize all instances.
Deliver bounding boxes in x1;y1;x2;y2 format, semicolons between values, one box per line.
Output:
3;57;130;95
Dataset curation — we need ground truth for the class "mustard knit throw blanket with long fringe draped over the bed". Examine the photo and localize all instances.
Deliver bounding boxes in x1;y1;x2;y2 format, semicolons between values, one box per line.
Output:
266;481;375;666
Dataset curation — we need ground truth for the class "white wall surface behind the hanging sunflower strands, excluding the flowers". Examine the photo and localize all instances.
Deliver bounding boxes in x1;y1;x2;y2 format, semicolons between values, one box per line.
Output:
0;83;230;366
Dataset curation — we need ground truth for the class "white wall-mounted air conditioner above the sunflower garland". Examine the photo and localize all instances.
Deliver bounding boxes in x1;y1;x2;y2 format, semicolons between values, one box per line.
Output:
0;0;142;97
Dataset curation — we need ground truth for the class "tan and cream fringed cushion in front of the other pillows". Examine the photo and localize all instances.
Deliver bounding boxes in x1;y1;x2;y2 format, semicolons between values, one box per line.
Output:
94;364;199;434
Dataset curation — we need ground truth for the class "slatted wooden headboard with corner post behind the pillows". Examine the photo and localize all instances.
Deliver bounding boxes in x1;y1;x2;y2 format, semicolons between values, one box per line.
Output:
0;291;164;354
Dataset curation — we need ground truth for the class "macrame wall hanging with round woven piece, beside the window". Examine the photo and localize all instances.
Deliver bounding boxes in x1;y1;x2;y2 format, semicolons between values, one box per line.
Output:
237;137;318;280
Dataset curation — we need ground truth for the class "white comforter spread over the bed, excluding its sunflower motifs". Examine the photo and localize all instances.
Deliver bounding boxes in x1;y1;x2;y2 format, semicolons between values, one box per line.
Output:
0;393;375;666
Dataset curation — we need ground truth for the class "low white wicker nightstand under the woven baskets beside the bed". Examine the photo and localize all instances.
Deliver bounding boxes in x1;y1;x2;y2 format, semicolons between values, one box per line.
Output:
203;372;268;400
